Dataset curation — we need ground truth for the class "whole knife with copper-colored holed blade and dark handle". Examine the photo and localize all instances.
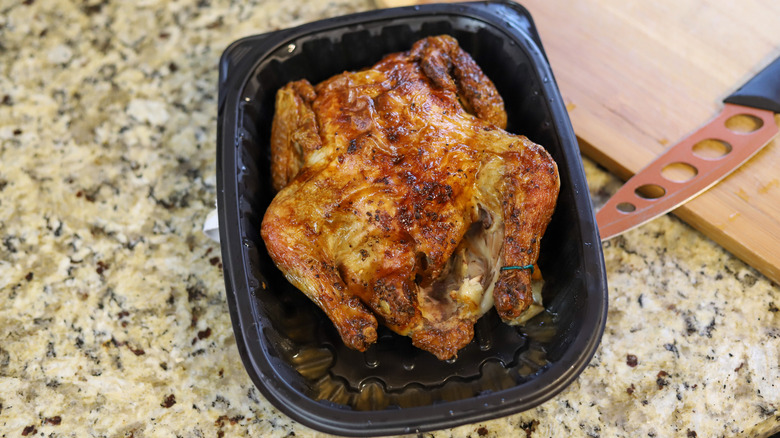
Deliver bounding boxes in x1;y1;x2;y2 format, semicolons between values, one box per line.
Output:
596;57;780;241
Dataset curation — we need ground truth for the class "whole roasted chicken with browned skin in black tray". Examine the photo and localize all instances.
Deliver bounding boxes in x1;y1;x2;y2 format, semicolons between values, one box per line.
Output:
261;36;560;360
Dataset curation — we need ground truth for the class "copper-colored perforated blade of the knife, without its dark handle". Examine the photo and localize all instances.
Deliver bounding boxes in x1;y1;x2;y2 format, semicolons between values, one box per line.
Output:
596;103;778;240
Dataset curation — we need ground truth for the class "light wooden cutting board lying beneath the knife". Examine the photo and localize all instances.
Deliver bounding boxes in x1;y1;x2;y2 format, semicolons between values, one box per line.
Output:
378;0;780;282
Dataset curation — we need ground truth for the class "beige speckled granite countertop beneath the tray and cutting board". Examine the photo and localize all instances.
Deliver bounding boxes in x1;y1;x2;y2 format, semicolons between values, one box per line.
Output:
0;0;780;437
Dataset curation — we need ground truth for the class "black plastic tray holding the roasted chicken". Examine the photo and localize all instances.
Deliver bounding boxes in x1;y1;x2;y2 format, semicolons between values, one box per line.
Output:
217;2;607;436
